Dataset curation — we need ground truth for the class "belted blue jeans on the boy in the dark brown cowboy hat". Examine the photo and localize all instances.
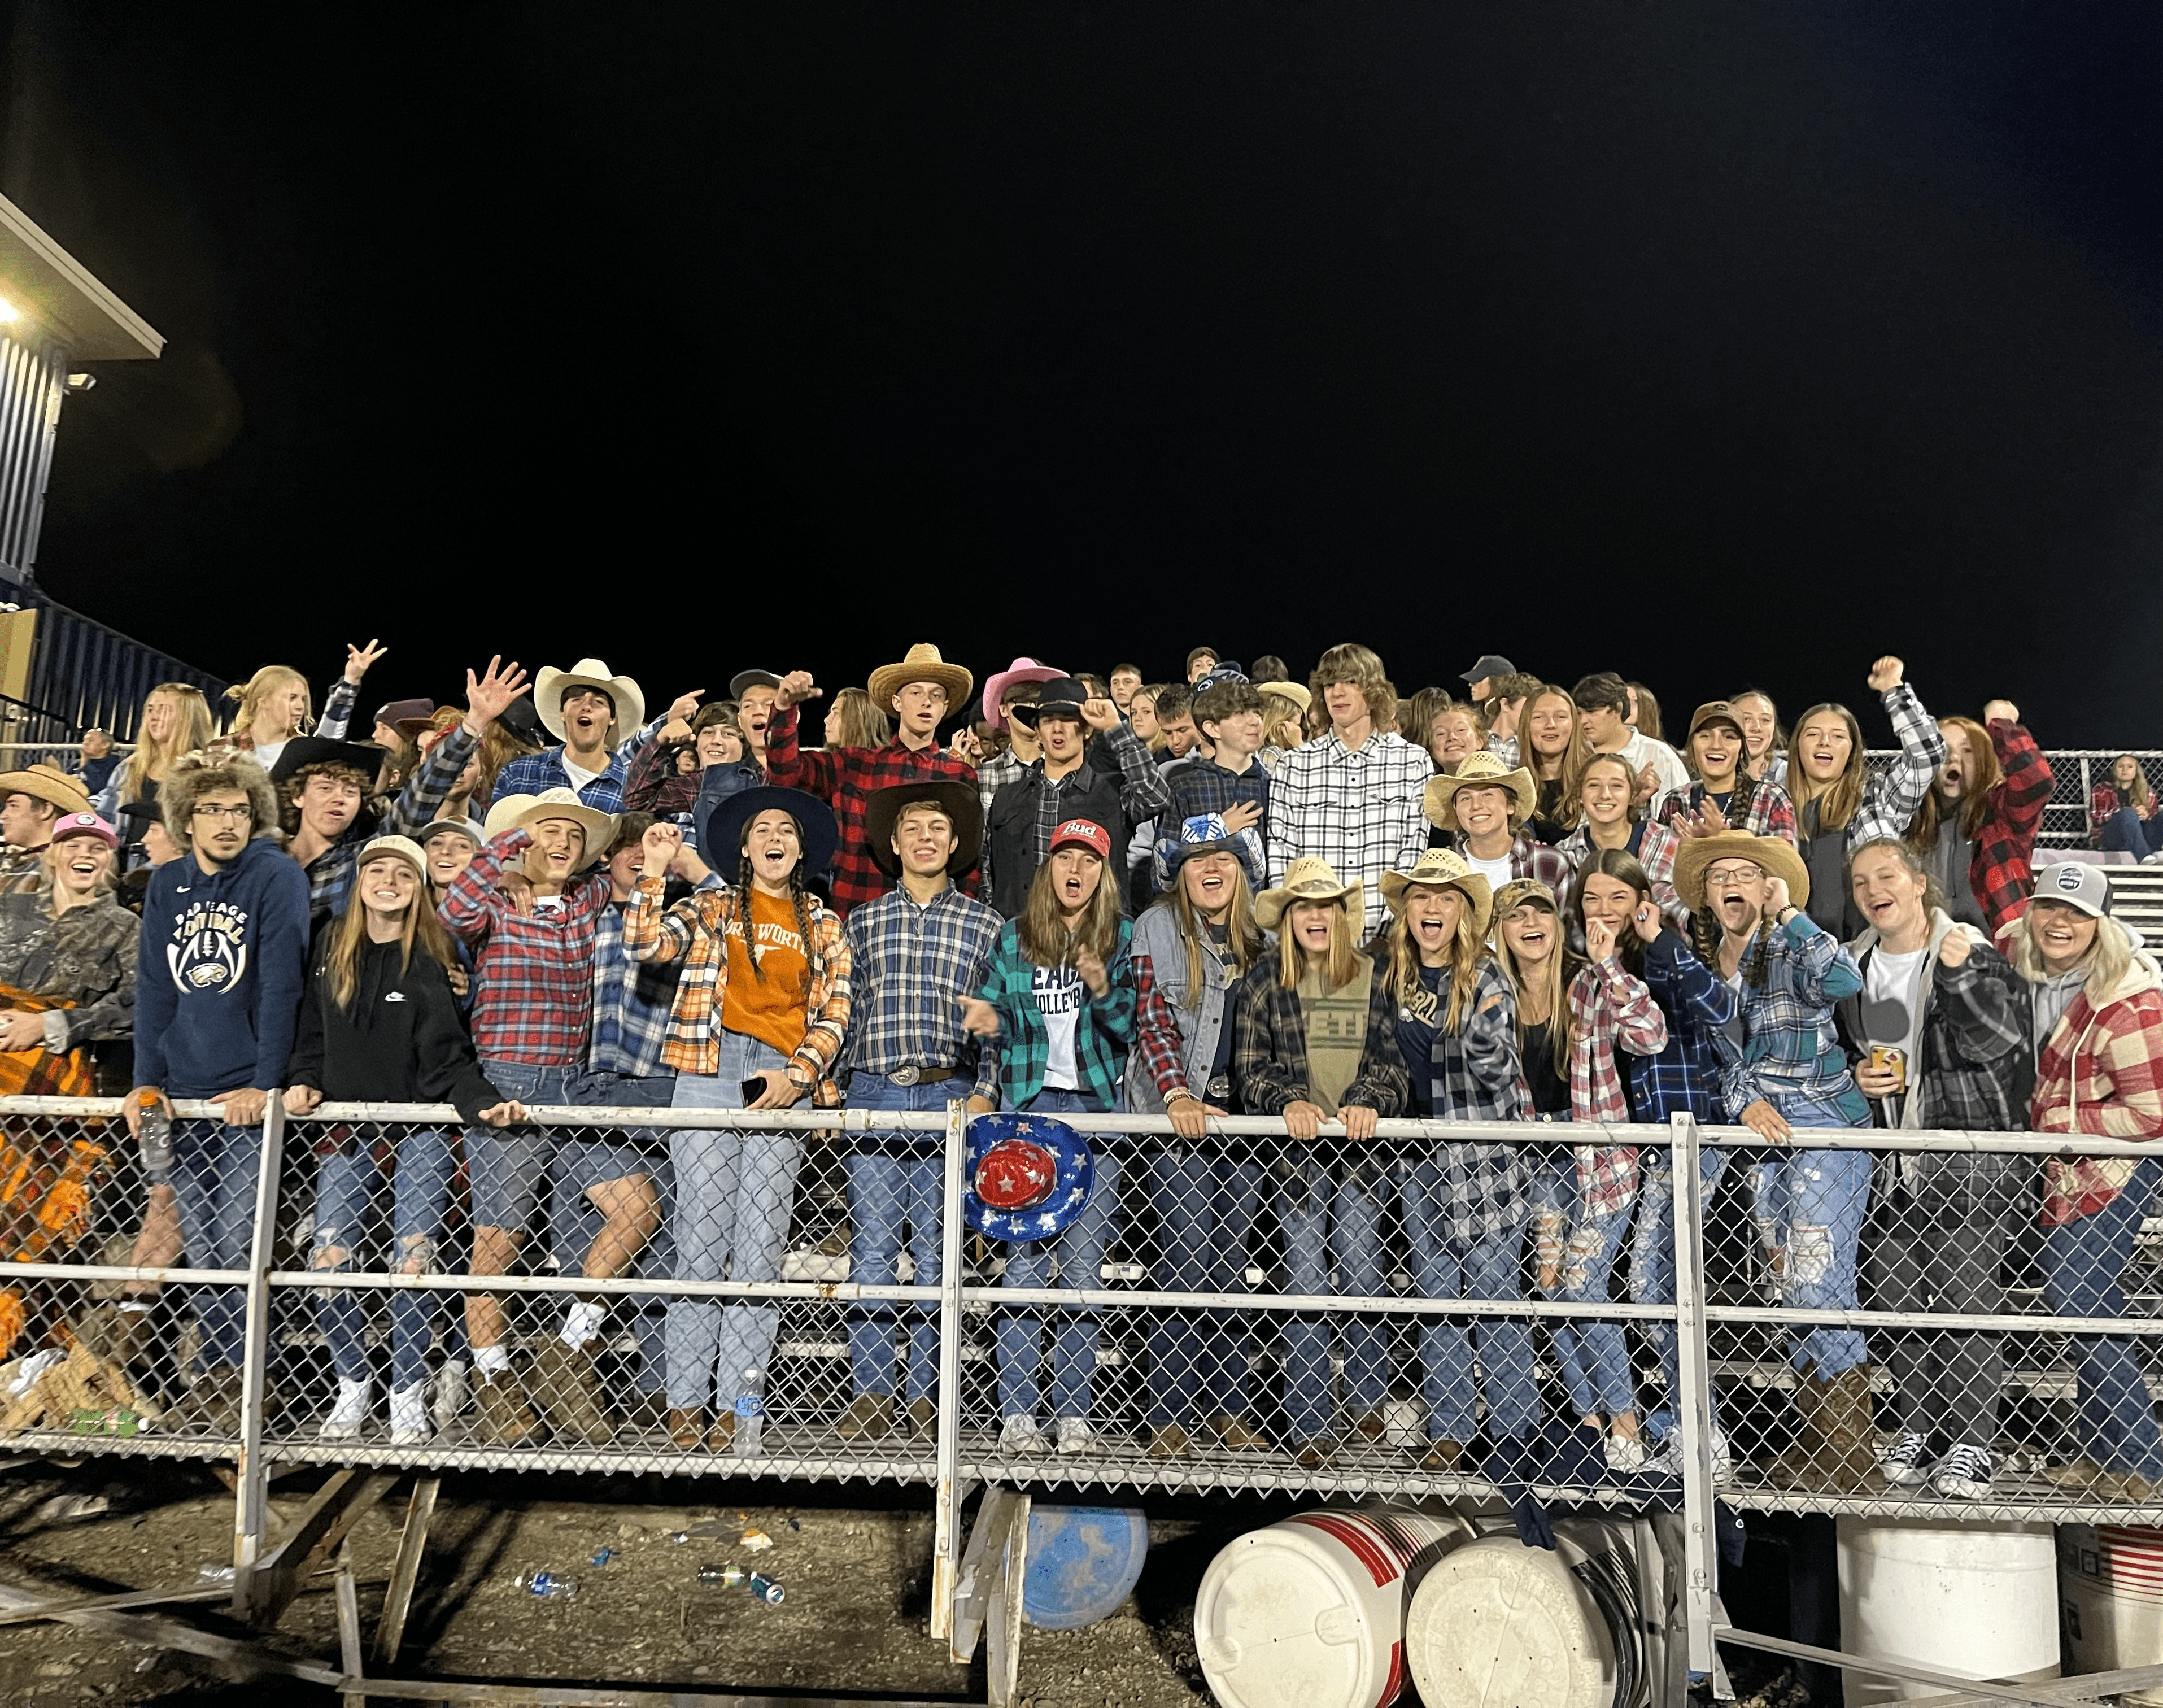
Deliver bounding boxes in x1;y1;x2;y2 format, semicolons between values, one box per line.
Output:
848;1073;952;1403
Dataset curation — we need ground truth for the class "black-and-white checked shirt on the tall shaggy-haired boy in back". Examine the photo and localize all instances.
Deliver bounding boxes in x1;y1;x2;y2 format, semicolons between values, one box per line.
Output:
1270;731;1434;936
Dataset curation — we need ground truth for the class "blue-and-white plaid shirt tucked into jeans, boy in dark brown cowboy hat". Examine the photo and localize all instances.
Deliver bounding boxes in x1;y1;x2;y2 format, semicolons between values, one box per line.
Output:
848;884;1004;1100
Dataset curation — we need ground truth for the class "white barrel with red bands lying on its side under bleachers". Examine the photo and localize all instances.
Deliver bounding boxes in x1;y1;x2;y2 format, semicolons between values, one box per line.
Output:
1194;1509;1471;1708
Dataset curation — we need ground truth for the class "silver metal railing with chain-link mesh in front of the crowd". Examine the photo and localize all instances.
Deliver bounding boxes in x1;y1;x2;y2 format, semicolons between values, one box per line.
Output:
0;1099;2163;1665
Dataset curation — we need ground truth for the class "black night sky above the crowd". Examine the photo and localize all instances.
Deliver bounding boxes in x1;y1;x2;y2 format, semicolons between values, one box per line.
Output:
0;0;2163;746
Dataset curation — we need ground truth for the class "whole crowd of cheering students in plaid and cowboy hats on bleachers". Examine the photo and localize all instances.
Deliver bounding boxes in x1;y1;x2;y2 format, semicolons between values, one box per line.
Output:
16;642;2163;1498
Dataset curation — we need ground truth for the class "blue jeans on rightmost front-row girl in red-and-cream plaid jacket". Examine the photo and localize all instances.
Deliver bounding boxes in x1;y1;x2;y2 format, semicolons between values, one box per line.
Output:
2042;1161;2163;1481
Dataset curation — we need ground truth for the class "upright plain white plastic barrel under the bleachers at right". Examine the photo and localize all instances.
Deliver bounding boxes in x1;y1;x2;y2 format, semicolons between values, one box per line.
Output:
1839;1518;2057;1708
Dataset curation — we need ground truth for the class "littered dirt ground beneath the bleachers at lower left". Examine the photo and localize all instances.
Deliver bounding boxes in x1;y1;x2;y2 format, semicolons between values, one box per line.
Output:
0;1459;1237;1708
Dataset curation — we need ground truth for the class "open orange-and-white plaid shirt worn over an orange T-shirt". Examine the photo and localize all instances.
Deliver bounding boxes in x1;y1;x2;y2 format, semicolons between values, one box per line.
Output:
623;875;850;1109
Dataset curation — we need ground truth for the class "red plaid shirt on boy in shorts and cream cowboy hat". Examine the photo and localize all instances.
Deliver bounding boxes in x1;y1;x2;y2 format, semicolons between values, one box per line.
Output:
437;826;608;1068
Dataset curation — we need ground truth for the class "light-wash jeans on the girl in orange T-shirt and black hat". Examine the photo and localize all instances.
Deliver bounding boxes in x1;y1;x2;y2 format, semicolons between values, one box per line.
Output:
666;1029;805;1412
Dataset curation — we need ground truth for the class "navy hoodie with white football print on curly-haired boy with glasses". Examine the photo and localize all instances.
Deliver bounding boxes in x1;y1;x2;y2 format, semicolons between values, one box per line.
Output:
134;836;307;1096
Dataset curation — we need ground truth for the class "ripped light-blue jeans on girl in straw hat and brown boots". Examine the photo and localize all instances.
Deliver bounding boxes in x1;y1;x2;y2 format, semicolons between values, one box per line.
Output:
1750;1112;1871;1382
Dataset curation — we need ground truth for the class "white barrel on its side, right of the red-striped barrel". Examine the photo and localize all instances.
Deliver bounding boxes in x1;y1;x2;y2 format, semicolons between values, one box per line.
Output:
1404;1520;1644;1708
